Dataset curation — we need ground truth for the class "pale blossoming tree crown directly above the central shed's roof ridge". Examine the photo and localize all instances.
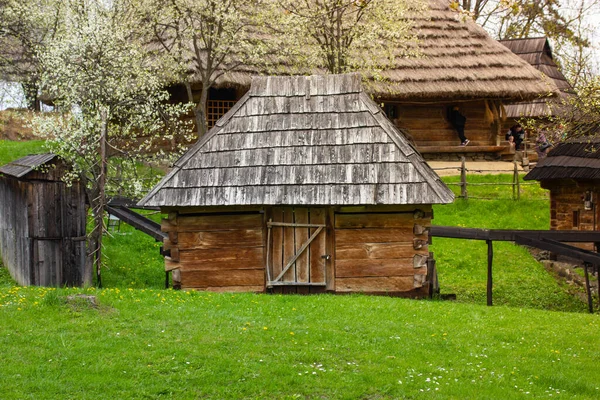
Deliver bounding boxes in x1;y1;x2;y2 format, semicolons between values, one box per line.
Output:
277;0;424;74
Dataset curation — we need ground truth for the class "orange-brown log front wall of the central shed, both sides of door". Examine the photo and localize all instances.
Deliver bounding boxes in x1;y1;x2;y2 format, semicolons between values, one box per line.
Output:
162;205;432;297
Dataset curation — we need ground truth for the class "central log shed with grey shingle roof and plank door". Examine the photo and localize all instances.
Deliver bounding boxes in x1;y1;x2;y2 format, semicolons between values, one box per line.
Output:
139;75;454;296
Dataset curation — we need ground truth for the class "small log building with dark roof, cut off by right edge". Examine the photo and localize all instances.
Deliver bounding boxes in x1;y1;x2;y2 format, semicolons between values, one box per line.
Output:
524;138;600;231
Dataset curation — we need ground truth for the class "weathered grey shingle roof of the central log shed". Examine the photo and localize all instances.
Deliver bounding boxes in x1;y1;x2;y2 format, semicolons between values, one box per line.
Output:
139;74;454;207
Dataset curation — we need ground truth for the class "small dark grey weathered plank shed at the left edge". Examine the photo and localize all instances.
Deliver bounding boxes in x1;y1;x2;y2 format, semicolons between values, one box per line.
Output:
0;154;92;286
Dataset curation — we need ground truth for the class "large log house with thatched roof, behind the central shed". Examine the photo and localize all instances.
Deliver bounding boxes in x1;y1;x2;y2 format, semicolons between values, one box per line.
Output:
173;0;558;159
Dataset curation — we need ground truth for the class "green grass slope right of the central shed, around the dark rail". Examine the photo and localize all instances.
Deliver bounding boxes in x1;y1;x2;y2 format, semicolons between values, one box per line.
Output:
431;175;586;312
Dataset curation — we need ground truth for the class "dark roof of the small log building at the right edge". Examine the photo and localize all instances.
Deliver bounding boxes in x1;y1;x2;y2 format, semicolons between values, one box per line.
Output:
524;137;600;181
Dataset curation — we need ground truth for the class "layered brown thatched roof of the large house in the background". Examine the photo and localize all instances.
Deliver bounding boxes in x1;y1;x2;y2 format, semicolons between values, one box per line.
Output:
196;0;558;102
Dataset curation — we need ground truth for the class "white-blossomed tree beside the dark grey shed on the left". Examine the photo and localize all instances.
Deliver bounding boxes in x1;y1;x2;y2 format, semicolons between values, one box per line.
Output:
35;0;189;285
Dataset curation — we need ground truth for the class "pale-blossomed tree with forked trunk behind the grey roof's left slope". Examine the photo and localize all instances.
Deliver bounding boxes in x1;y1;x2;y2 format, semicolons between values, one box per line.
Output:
139;0;269;137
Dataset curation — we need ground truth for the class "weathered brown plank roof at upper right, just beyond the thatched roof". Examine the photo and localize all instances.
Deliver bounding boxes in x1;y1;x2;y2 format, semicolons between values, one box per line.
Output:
500;37;574;118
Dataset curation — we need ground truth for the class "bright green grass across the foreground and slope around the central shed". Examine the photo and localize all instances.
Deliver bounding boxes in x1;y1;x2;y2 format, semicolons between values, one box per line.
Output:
0;140;600;399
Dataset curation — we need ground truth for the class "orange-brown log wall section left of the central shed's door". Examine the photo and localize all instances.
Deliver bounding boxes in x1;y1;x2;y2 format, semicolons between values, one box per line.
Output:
162;211;265;292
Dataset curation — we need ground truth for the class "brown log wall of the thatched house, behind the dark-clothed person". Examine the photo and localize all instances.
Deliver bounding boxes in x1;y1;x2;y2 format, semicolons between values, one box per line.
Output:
393;101;496;147
